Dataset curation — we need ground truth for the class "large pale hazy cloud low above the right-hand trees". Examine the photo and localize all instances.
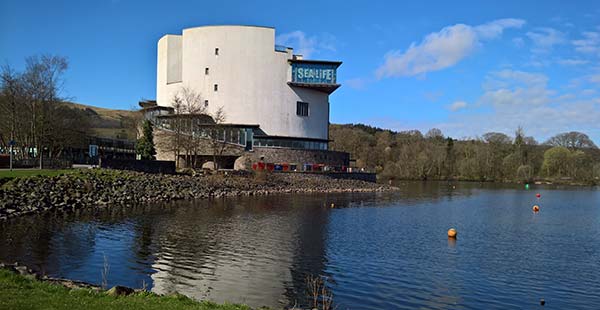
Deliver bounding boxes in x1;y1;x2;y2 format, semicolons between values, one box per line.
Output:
435;70;600;141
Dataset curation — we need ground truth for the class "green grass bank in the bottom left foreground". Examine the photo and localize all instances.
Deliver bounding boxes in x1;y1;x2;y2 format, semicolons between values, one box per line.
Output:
0;269;250;310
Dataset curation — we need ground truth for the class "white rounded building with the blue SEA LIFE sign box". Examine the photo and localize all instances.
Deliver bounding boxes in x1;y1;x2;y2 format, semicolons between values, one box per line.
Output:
156;26;341;150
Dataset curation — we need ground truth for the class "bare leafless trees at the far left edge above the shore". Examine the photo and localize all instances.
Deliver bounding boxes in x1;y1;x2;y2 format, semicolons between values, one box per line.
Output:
0;55;89;167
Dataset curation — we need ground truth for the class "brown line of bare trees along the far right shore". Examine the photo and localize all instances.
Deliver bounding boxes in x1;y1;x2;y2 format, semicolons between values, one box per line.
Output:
330;124;600;184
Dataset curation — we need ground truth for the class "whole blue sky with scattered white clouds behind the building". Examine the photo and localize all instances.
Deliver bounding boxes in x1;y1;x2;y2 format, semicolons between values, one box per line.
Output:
0;0;600;145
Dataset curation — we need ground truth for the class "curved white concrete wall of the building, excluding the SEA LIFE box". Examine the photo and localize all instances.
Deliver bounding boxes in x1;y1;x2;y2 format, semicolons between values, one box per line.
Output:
157;26;329;139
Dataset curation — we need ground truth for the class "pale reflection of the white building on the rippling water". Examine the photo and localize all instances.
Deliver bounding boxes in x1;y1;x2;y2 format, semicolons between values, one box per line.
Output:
145;196;330;306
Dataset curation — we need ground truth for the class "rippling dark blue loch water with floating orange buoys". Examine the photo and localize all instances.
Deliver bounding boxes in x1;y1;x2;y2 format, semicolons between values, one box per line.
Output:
0;182;600;309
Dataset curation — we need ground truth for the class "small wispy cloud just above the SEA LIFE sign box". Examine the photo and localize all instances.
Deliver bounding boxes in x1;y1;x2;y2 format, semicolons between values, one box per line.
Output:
275;30;336;58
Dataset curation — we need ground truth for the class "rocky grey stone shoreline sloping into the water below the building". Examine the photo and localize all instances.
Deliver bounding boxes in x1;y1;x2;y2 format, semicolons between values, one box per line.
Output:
0;169;396;221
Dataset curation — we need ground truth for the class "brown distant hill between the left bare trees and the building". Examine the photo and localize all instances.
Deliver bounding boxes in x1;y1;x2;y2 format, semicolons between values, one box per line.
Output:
65;102;139;140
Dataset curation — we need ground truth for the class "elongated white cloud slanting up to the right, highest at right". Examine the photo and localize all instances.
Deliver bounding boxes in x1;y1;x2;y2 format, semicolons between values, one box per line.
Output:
376;18;525;78
